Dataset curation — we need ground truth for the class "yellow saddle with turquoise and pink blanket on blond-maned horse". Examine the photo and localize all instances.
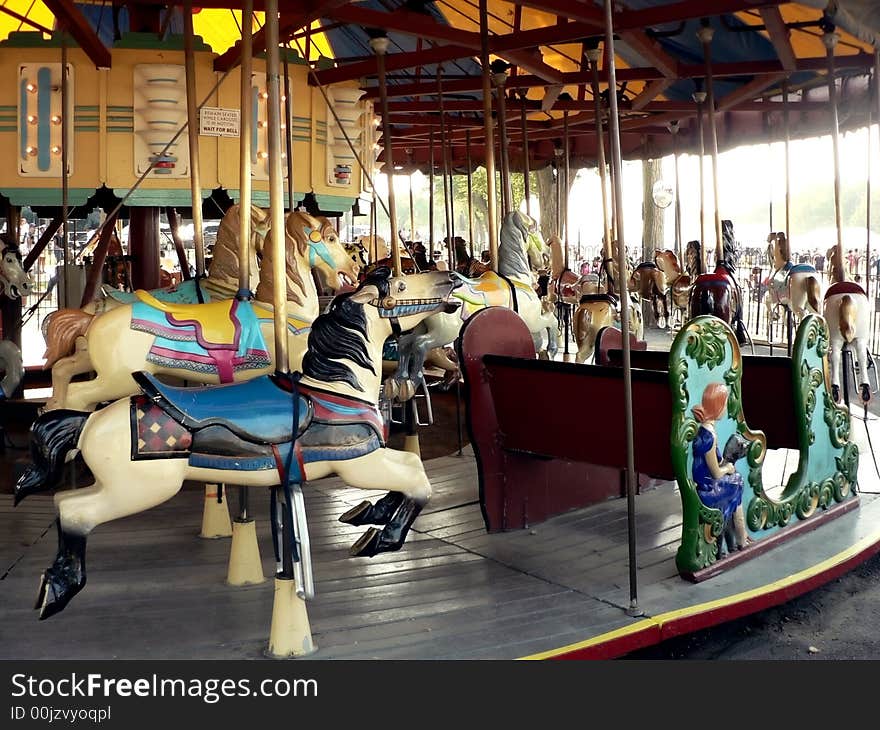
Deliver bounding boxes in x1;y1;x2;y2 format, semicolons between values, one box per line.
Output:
131;291;272;383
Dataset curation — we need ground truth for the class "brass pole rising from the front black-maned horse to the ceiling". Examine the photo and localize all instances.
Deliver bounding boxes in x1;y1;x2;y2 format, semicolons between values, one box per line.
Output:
263;0;290;372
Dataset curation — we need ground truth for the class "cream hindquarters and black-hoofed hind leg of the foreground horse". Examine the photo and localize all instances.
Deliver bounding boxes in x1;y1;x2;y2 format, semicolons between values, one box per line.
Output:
36;400;187;619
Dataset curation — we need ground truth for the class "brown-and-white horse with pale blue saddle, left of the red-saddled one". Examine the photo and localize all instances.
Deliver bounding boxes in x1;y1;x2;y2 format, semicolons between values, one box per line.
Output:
764;231;822;327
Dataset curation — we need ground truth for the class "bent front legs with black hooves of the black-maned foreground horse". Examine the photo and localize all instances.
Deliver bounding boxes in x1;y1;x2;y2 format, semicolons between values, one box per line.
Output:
336;448;431;557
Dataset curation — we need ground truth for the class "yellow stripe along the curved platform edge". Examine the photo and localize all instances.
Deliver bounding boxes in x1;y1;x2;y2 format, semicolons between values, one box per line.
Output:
518;530;880;661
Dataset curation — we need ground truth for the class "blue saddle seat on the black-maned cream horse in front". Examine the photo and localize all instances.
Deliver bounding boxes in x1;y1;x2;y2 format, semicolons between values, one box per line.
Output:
132;371;313;444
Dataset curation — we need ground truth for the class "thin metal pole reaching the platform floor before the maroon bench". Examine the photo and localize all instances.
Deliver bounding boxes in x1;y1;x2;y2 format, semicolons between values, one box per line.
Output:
605;0;641;616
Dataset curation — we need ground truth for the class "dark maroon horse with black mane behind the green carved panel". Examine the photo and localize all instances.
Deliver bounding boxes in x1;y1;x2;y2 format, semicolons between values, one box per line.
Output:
688;220;752;345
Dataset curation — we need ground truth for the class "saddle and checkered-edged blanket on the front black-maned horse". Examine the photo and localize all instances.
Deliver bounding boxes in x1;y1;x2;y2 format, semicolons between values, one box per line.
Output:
130;372;387;482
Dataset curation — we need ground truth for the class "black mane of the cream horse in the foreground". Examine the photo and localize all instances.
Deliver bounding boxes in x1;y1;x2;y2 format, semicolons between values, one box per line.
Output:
302;267;391;392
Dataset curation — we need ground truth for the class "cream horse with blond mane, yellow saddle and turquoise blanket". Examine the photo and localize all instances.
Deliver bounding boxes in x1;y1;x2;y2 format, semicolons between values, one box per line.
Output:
46;211;358;411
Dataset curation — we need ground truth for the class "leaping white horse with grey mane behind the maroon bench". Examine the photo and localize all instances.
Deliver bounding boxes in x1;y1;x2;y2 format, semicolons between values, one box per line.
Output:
387;211;558;400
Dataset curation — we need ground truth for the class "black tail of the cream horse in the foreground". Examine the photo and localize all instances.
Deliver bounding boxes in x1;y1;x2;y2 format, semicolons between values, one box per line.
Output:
15;408;91;504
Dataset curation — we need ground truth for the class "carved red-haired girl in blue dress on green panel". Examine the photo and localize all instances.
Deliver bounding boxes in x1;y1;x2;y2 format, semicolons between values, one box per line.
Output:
692;383;750;550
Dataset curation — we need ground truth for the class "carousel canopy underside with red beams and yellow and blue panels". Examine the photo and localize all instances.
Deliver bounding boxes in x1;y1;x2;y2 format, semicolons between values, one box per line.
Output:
0;0;880;170
